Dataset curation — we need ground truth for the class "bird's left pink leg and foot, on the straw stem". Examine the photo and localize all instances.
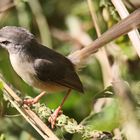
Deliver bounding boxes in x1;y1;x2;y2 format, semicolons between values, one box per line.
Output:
23;91;46;105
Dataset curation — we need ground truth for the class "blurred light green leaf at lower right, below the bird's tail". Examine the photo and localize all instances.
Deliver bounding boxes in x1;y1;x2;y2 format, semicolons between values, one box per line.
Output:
82;100;120;131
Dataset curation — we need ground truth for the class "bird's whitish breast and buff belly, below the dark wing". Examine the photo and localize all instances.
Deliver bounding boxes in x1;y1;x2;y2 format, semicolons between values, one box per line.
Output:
10;53;67;91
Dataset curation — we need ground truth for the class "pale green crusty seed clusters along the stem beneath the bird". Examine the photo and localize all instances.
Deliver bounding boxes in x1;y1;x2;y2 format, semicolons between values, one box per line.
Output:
33;103;111;139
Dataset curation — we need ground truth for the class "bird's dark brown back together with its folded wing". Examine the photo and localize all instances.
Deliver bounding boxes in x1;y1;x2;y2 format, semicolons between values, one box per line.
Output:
27;42;83;92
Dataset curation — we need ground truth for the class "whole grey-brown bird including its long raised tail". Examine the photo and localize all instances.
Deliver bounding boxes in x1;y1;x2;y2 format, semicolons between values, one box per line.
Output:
0;8;140;127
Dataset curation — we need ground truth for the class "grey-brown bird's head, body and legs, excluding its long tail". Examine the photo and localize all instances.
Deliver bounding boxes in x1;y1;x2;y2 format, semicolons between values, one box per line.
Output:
0;26;84;128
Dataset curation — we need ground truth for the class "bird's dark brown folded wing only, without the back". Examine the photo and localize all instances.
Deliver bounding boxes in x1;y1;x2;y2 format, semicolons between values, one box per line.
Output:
34;59;83;92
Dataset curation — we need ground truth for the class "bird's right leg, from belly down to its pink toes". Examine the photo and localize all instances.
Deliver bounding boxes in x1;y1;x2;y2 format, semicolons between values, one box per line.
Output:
48;89;71;128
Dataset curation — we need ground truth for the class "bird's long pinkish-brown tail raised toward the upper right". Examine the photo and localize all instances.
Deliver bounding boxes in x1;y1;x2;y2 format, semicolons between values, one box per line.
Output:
68;8;140;65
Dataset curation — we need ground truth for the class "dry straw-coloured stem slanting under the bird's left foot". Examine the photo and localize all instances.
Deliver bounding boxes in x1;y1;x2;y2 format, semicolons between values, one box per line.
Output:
0;76;58;140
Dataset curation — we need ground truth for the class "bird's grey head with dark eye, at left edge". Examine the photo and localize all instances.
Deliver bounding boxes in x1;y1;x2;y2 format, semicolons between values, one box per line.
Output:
0;26;34;51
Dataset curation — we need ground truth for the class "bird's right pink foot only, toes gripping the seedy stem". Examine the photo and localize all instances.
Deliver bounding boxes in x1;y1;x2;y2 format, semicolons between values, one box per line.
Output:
48;106;62;128
